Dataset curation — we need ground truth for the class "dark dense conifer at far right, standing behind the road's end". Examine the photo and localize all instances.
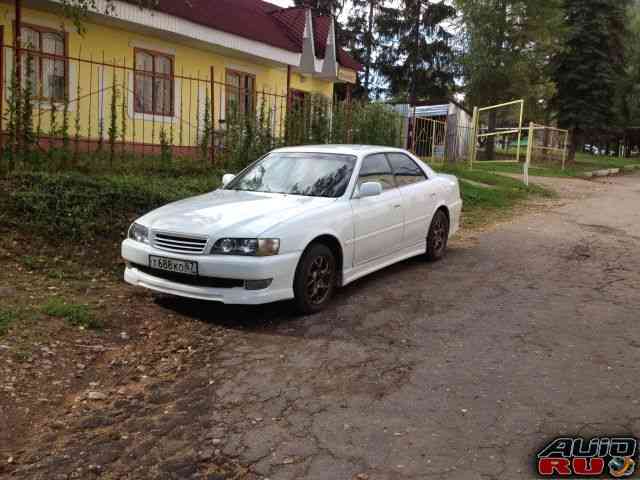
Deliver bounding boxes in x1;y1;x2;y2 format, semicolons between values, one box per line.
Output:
553;0;629;160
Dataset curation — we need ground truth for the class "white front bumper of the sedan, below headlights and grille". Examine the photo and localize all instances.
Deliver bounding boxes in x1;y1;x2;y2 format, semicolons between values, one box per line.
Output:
122;239;301;305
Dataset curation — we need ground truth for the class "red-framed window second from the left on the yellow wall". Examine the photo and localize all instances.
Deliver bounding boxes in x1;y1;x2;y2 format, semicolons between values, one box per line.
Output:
134;49;175;117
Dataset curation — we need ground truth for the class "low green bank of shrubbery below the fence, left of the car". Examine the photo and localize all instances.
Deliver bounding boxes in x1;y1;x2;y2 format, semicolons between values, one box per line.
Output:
0;173;219;243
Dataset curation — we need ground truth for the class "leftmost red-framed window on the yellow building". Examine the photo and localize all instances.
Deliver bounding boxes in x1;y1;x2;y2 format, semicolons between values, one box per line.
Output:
21;26;67;101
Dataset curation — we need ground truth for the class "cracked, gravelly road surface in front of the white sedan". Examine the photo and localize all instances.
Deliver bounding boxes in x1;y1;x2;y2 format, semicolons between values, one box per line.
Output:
0;176;640;480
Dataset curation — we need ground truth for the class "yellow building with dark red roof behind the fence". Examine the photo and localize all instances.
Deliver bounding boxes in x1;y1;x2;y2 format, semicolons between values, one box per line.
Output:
0;0;360;156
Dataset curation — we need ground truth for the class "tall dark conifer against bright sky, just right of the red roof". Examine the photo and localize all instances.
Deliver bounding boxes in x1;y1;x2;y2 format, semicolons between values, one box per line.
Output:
376;0;456;103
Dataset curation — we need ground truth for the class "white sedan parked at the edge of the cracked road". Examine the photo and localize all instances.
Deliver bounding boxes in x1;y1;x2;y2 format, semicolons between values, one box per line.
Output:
122;145;462;313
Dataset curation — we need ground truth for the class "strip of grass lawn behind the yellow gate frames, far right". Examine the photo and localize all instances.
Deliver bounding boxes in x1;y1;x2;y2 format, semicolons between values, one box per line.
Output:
473;153;640;177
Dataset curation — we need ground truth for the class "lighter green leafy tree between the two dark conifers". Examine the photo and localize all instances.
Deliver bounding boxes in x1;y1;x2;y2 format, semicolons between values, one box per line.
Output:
456;0;562;159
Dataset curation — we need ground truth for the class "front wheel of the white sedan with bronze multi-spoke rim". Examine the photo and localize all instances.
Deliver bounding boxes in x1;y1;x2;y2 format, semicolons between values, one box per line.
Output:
293;243;337;315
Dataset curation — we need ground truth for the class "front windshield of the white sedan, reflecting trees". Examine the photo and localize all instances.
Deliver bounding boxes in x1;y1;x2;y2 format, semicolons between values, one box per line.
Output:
226;152;356;198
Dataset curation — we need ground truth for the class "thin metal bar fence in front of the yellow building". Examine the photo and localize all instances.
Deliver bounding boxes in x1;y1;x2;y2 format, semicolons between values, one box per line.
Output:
0;46;351;171
